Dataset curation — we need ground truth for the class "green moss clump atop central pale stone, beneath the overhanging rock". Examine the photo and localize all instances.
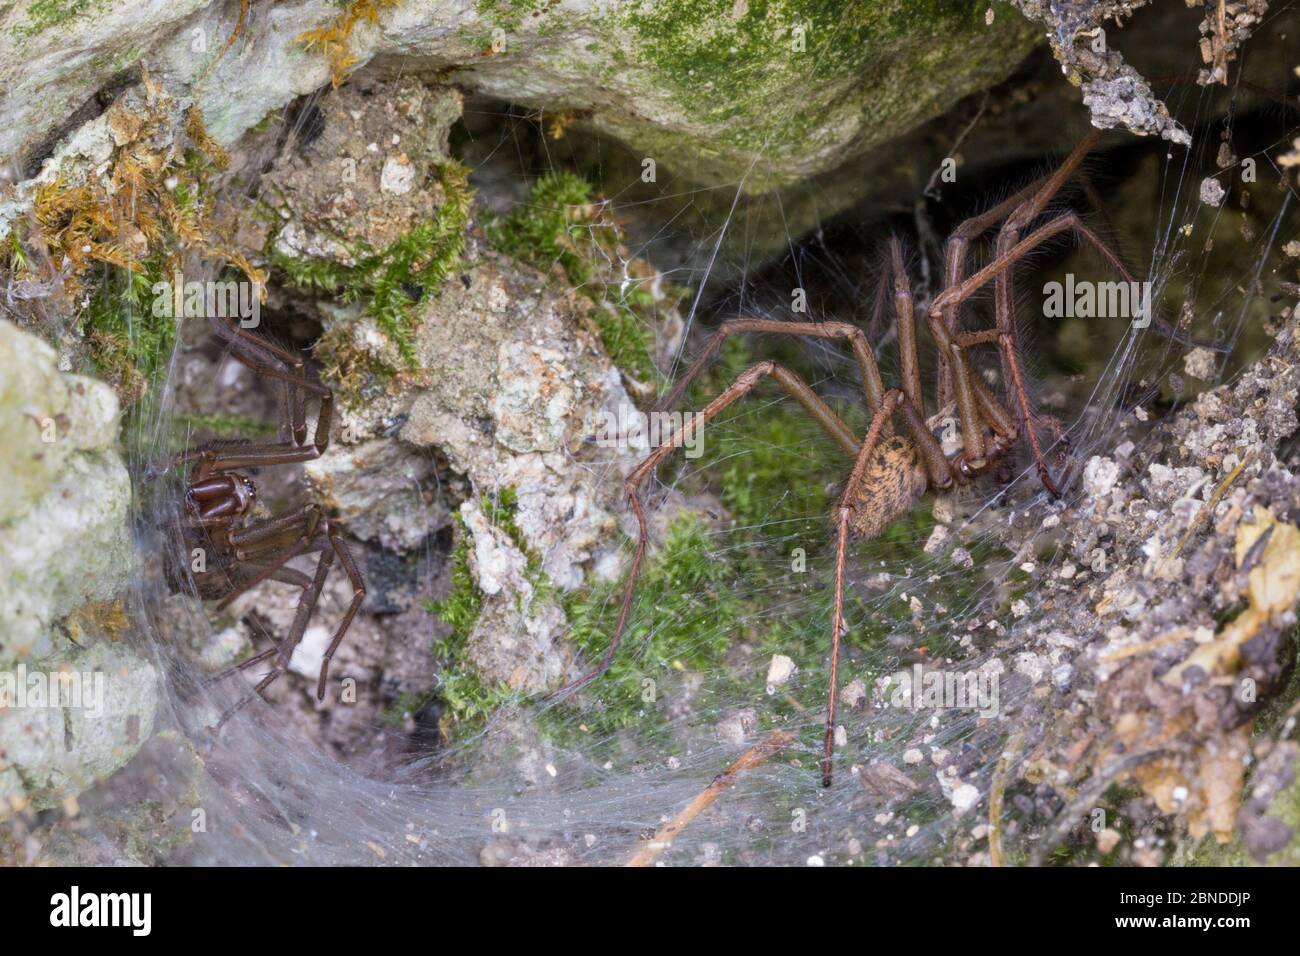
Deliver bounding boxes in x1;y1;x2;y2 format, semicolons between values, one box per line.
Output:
488;172;683;384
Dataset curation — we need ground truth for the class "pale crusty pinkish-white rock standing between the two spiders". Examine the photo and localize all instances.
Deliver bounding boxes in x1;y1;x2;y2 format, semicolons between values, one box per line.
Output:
399;254;637;588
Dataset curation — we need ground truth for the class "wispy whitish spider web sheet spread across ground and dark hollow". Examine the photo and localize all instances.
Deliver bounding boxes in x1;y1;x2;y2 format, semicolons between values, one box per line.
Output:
58;5;1296;865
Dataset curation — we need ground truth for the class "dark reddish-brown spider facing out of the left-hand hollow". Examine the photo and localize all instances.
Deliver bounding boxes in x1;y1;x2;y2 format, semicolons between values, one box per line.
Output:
172;319;365;726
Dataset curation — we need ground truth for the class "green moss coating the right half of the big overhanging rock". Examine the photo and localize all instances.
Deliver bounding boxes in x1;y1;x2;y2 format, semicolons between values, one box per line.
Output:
620;0;1032;167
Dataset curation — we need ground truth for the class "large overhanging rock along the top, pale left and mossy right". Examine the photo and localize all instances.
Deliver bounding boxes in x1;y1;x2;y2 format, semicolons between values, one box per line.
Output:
0;0;1034;196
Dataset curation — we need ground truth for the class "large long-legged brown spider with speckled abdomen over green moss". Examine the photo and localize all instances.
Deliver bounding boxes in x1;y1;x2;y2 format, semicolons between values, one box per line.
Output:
547;131;1179;787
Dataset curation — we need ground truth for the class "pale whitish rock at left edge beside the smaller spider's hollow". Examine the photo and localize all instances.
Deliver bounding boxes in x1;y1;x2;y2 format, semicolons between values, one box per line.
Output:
0;320;156;817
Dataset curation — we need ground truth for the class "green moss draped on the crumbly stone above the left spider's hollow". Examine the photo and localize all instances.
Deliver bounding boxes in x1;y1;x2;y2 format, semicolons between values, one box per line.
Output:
278;163;473;395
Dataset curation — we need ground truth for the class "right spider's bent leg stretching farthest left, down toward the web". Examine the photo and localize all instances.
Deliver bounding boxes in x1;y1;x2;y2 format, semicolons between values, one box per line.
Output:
543;358;861;701
